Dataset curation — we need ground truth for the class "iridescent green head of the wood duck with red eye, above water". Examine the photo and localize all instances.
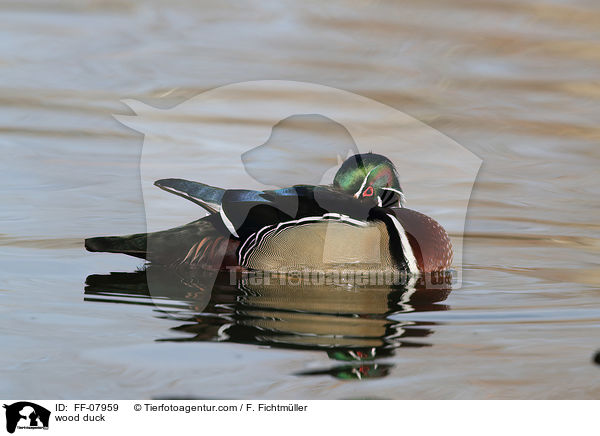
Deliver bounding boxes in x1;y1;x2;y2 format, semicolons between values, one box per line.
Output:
333;153;405;207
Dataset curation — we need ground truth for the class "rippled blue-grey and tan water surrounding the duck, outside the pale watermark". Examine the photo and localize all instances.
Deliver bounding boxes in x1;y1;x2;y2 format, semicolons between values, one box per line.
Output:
0;0;600;399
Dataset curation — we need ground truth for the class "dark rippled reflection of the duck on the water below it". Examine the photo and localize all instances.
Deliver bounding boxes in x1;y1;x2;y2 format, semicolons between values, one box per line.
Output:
85;266;451;380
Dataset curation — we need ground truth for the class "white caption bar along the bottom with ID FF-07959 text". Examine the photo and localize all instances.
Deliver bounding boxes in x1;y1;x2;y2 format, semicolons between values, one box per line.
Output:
0;400;599;436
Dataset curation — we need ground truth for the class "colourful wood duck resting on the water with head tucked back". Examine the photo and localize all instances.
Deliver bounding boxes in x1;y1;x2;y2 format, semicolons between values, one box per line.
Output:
85;153;452;274
